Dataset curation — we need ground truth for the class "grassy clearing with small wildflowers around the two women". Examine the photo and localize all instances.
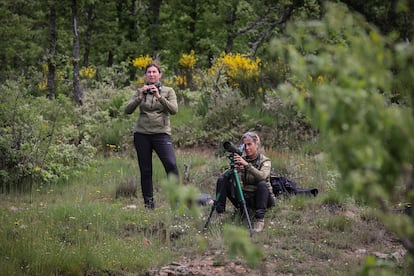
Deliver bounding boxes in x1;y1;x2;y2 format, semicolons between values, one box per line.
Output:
0;149;412;275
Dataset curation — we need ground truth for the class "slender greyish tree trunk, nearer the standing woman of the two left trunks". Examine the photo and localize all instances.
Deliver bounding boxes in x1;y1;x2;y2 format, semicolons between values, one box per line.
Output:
72;0;83;106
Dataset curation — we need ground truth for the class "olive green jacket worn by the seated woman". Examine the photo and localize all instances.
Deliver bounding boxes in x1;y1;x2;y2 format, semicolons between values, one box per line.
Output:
240;154;273;194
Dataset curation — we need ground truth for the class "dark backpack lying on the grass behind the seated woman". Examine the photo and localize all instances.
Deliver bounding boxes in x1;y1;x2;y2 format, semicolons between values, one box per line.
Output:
270;175;318;197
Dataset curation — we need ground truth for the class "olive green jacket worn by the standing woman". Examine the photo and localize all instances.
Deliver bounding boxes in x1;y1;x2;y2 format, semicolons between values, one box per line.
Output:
125;86;178;135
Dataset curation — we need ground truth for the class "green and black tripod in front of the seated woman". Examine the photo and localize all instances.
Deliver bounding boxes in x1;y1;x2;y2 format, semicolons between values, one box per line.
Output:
204;152;253;237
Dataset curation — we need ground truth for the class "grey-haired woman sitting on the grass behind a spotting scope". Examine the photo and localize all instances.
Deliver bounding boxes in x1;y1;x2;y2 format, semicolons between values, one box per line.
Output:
216;132;276;232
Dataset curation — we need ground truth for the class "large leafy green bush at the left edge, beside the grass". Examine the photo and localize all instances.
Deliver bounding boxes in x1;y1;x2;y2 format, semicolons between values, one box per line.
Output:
0;82;95;191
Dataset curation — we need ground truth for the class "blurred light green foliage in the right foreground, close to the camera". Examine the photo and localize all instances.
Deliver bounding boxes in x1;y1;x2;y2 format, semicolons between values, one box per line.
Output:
274;1;414;254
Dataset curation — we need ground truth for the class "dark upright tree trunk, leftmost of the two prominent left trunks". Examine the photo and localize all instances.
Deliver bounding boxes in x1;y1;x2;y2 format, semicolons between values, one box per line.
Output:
46;3;57;100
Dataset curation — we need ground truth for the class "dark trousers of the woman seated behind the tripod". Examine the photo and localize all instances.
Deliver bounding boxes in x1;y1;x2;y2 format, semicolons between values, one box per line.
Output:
216;173;275;219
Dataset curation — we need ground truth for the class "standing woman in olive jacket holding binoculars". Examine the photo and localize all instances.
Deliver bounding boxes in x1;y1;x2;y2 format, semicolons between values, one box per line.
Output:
125;63;179;209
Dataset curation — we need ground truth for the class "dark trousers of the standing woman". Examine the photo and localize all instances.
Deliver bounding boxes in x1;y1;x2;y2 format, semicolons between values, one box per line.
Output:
134;132;179;207
